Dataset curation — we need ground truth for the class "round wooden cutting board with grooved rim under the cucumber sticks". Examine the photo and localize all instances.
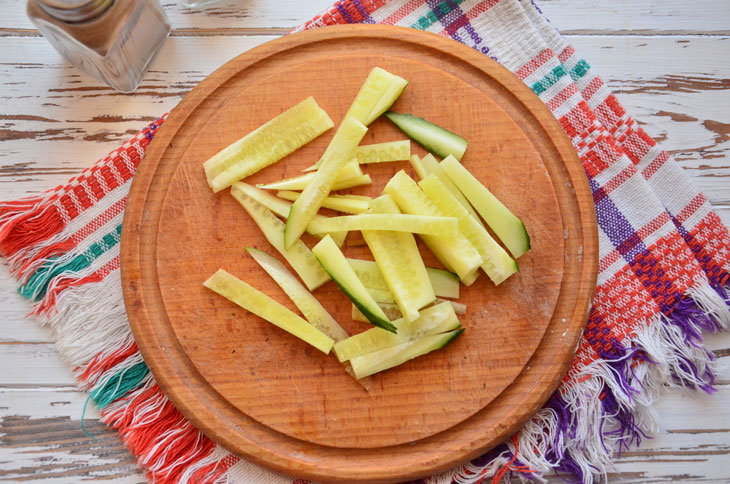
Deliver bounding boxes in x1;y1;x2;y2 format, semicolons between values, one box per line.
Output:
122;25;597;482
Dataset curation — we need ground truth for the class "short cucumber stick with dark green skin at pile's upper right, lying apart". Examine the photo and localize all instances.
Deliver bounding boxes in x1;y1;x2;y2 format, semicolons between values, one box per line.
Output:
385;111;469;160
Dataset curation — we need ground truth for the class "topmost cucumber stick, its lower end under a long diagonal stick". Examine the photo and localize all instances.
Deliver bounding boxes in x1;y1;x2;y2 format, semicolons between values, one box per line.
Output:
345;67;408;126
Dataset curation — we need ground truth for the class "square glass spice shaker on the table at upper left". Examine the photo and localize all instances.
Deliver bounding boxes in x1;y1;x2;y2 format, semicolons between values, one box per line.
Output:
27;0;170;92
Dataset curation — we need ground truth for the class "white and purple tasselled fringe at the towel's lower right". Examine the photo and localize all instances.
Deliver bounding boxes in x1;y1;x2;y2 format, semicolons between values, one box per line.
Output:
426;283;729;484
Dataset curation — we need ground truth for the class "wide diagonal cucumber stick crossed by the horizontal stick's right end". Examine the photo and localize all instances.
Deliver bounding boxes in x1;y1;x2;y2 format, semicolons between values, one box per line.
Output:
385;170;483;280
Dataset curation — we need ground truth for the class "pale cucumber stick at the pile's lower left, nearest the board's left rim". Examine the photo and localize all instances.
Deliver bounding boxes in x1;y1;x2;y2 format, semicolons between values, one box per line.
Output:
203;269;335;354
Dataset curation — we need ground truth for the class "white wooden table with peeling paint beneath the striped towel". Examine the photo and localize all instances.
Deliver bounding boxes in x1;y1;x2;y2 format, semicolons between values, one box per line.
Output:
0;0;730;484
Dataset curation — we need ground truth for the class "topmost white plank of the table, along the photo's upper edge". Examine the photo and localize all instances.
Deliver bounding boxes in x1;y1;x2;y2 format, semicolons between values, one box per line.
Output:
0;0;730;35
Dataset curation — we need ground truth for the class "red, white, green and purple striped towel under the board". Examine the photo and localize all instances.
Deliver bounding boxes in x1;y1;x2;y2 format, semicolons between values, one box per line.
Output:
0;0;730;484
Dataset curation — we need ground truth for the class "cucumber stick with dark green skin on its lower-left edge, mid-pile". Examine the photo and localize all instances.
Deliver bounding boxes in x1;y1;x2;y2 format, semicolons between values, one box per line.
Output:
312;236;396;333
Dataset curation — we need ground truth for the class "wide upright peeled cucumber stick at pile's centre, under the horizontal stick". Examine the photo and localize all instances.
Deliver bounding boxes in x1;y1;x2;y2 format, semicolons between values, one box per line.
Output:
360;195;436;321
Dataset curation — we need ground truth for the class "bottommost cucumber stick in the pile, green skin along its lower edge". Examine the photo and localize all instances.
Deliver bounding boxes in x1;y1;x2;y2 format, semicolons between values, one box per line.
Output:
350;328;464;379
